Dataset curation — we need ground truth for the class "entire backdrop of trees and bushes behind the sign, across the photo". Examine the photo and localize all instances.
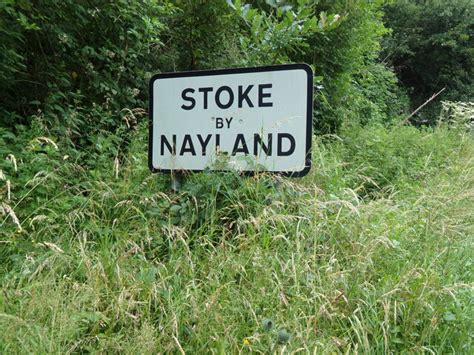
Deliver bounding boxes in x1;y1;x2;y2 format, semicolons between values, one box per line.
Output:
0;0;474;139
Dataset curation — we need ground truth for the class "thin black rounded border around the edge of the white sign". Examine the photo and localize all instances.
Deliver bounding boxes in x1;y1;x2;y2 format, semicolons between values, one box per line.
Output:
148;63;313;177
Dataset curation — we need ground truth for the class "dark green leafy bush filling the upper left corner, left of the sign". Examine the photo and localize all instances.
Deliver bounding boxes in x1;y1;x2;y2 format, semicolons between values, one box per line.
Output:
0;0;167;134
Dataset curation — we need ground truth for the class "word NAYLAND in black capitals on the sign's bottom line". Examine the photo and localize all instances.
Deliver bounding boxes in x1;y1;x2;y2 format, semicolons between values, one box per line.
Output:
159;133;296;156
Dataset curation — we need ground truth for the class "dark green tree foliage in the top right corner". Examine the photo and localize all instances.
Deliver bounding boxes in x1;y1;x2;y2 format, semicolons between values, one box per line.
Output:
383;0;474;122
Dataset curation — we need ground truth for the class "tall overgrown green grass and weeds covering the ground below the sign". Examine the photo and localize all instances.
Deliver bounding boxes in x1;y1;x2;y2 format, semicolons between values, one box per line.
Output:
0;127;474;353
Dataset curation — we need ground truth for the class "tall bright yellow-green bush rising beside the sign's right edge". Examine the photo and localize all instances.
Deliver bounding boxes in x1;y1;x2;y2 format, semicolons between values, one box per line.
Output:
286;1;404;133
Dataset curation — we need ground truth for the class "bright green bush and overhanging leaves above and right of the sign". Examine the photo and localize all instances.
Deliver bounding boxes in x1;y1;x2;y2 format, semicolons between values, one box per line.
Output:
227;1;406;133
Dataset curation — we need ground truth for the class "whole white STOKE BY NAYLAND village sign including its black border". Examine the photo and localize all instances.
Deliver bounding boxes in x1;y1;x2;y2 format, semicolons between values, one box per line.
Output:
149;64;313;176
